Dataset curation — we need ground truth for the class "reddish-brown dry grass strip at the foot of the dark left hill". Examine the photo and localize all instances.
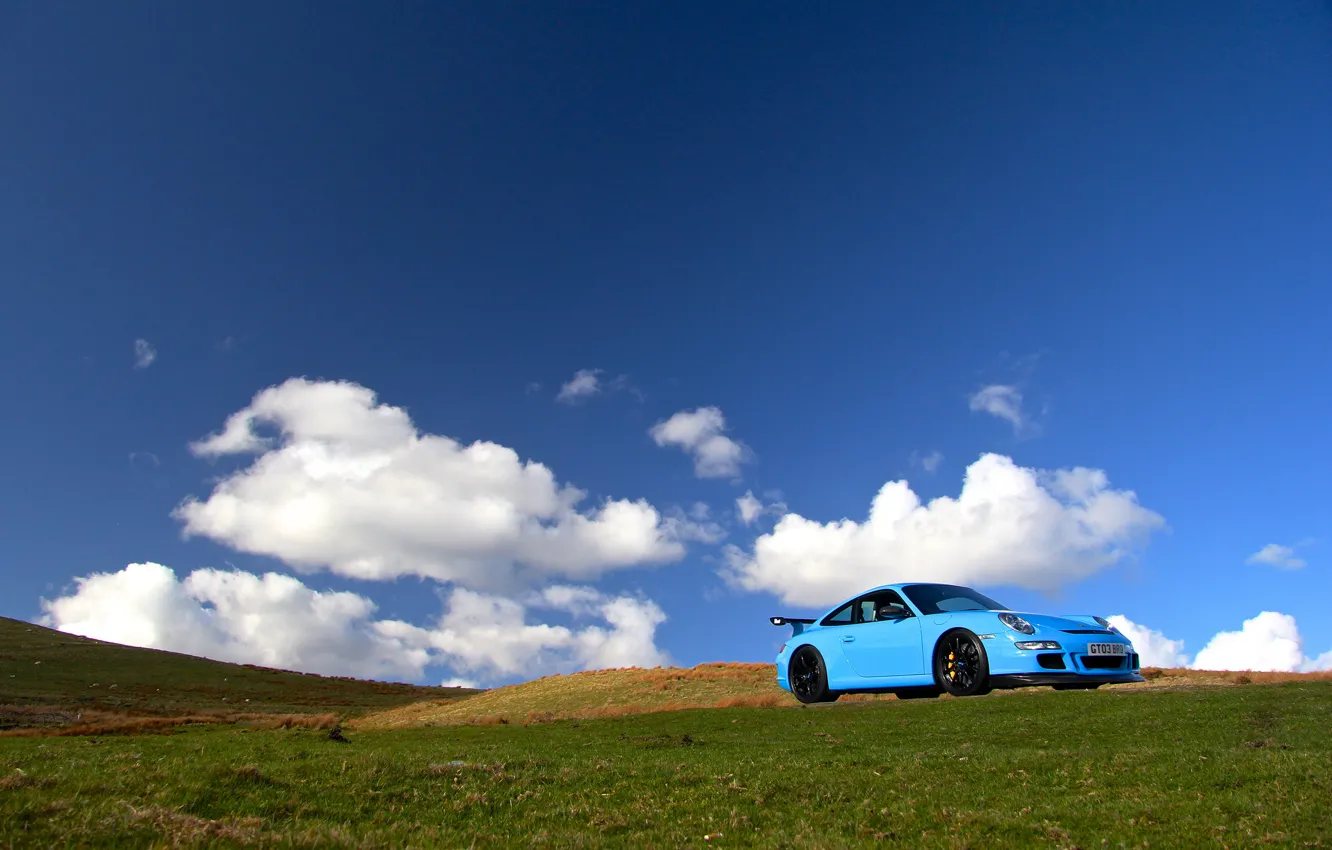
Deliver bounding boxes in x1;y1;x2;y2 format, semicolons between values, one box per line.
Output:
0;706;338;738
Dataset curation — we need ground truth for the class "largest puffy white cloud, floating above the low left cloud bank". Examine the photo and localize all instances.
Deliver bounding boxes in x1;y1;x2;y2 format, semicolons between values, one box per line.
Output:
173;378;685;589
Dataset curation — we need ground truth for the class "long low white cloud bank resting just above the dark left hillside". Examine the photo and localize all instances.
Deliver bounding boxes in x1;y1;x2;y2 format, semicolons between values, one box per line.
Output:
43;564;670;686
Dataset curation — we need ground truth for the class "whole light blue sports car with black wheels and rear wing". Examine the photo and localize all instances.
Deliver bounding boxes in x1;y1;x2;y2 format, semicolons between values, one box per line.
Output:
771;584;1143;702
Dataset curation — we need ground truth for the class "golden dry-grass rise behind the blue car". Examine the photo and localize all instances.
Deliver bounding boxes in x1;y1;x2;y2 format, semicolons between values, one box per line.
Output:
349;662;1332;729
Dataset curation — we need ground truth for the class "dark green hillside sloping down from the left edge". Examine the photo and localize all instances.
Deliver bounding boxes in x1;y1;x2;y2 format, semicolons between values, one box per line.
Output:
0;617;477;729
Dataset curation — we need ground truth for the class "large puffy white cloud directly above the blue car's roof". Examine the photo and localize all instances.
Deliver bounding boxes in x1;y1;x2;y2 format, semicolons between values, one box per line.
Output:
722;454;1164;606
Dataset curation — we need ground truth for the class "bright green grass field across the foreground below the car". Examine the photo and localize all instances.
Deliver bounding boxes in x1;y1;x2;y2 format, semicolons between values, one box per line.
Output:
0;682;1332;849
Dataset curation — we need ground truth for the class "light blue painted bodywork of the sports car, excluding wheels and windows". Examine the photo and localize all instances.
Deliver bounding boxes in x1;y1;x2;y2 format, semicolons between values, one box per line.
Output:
771;582;1143;693
